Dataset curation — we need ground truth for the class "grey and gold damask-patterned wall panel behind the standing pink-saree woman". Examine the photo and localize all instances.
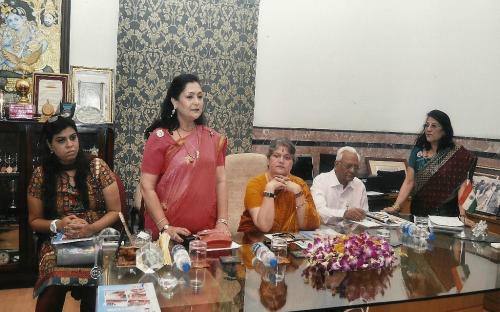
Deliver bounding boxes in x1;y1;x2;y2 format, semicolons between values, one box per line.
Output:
115;0;259;194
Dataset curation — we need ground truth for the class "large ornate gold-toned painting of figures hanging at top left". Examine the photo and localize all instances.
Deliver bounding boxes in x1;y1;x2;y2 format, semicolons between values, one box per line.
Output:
0;0;71;94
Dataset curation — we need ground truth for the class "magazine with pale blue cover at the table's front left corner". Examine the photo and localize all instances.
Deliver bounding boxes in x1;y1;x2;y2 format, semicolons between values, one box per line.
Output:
96;283;161;312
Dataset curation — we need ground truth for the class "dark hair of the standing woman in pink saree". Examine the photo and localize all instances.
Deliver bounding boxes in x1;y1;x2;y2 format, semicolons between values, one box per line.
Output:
144;74;207;139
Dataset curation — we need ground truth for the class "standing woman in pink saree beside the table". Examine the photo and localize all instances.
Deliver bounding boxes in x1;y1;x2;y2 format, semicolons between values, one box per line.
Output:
140;74;230;242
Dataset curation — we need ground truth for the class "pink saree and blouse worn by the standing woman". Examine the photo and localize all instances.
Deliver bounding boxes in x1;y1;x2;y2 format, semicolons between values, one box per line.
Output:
142;125;227;237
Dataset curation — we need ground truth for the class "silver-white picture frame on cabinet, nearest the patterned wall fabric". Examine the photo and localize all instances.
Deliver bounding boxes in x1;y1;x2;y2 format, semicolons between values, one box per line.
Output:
71;66;114;124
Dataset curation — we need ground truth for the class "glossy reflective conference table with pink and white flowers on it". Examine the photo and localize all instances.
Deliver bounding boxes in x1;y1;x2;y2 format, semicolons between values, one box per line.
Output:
100;217;500;311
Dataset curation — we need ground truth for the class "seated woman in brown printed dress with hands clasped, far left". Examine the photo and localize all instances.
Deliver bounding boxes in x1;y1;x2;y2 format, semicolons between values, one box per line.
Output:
28;116;121;311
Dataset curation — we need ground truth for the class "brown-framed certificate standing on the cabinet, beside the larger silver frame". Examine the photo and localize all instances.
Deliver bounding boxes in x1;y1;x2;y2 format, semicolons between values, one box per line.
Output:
33;73;69;115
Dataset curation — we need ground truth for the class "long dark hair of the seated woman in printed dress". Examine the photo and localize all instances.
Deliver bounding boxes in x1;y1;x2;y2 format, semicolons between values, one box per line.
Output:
39;116;90;219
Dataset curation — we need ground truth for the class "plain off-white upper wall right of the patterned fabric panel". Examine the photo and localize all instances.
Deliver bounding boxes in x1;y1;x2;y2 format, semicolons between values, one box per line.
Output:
254;0;500;139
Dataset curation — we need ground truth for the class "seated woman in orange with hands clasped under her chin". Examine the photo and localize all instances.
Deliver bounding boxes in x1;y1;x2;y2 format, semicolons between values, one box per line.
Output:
238;139;319;232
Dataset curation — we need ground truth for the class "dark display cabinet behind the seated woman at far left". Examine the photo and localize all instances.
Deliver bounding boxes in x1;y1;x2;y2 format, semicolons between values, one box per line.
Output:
0;121;114;289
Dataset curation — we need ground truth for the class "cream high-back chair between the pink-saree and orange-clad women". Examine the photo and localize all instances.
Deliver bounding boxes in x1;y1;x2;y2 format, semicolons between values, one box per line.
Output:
226;153;267;235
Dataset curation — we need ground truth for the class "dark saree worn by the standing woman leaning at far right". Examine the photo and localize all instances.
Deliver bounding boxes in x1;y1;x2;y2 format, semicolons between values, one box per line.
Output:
411;146;477;216
